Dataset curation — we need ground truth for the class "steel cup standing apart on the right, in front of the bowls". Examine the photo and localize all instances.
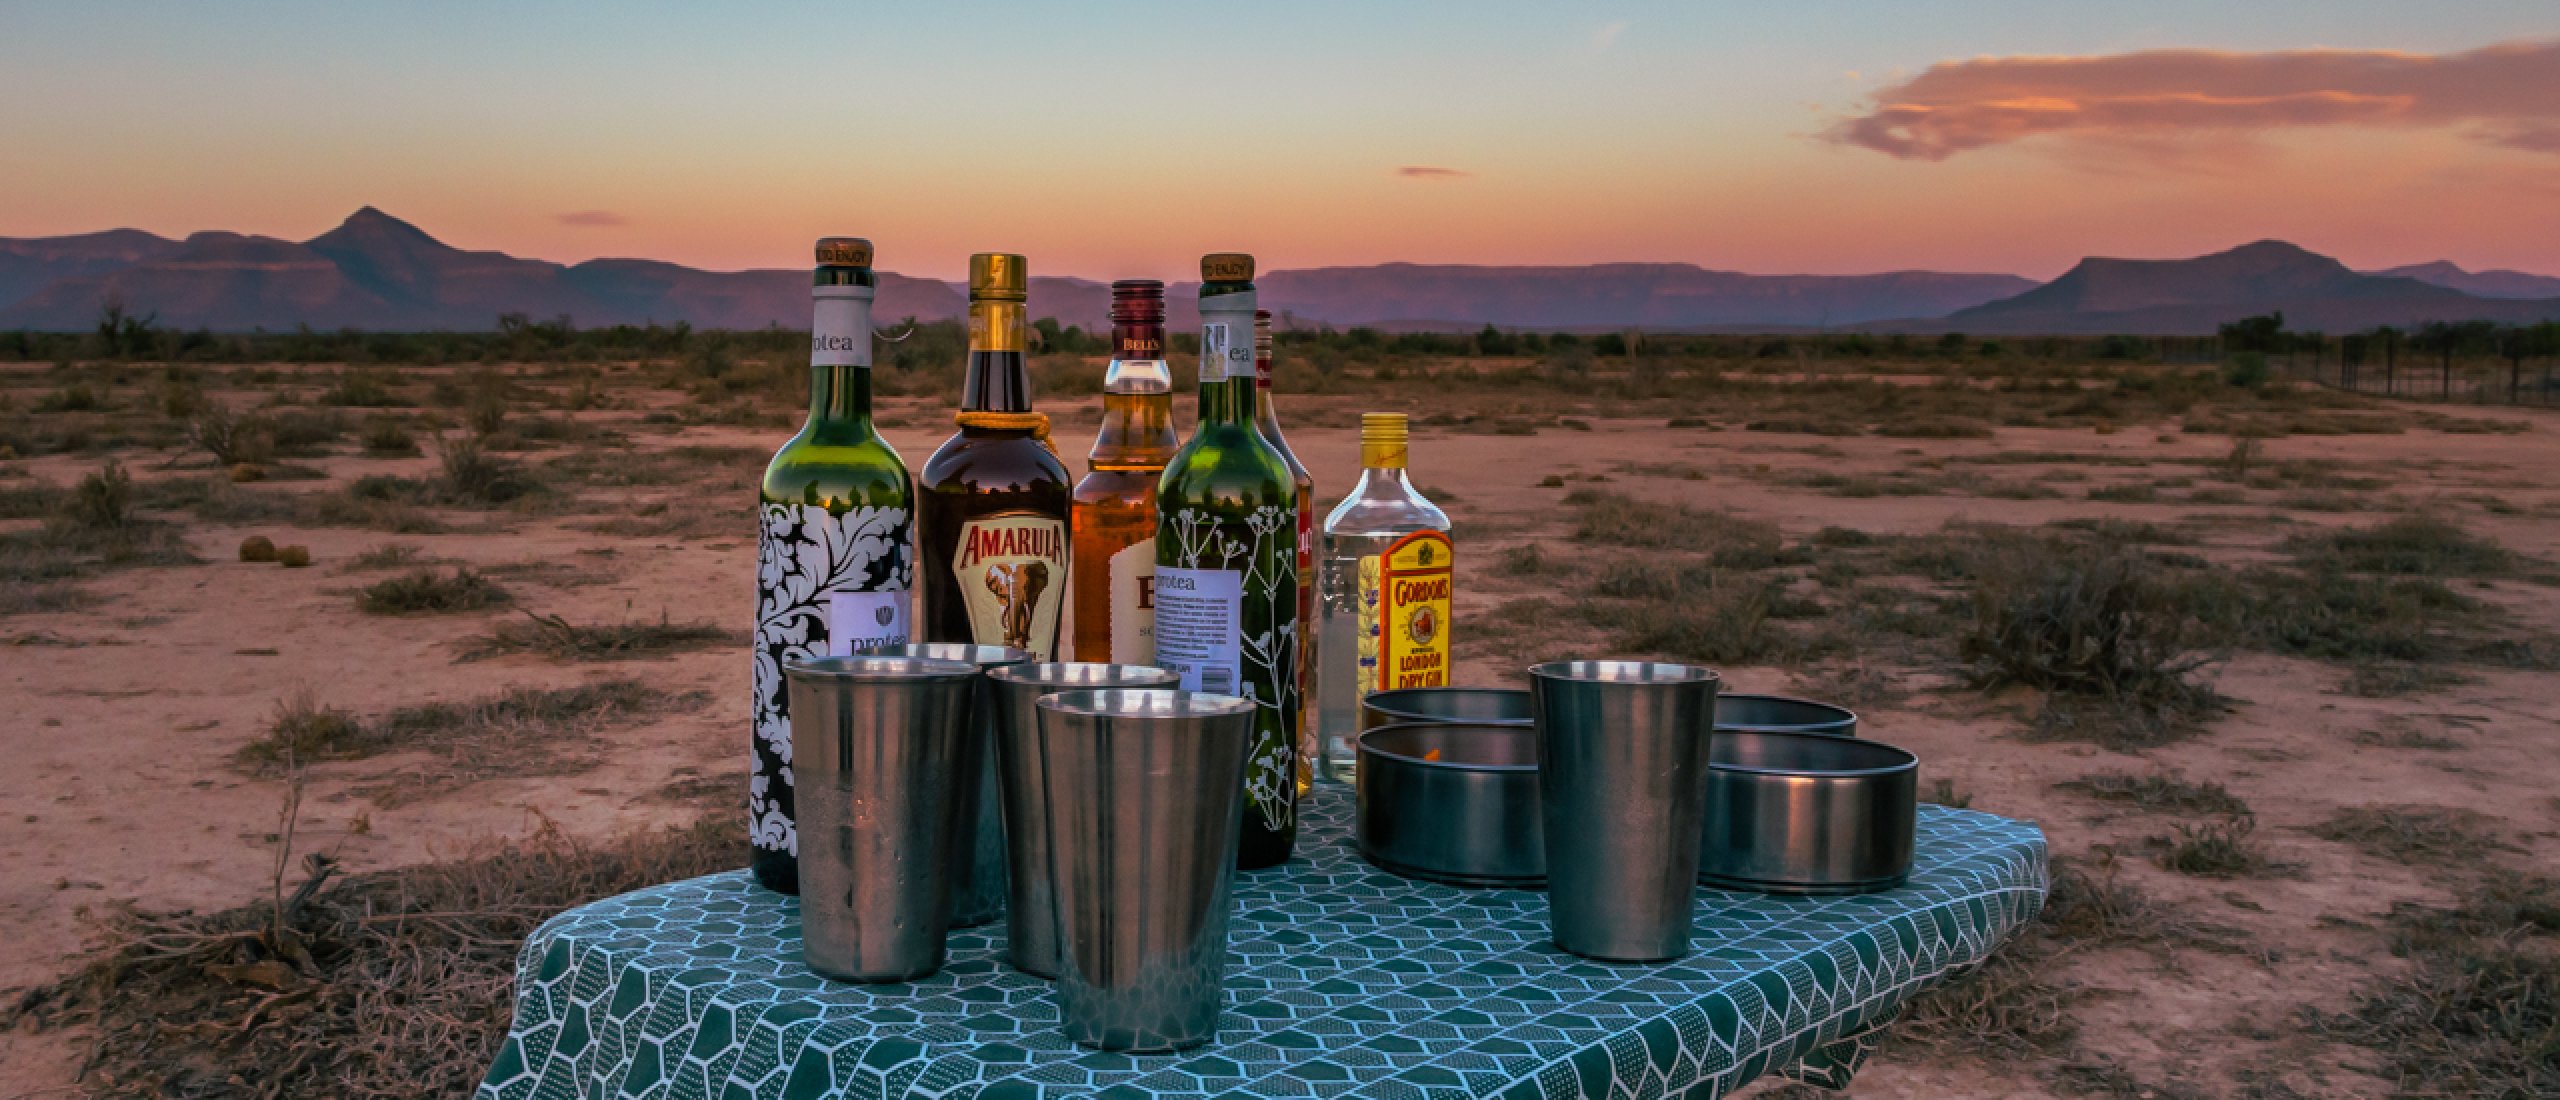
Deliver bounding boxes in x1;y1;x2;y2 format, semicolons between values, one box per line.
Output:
1528;660;1720;962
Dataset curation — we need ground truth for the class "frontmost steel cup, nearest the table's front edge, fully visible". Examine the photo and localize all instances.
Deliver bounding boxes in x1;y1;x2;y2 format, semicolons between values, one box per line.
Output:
1039;688;1259;1051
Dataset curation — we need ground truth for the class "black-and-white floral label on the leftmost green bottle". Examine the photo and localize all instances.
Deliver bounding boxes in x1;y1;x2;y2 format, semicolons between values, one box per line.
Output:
748;501;909;857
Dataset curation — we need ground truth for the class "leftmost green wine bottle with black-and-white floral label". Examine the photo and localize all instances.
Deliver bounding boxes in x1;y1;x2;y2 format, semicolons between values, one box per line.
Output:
748;238;914;893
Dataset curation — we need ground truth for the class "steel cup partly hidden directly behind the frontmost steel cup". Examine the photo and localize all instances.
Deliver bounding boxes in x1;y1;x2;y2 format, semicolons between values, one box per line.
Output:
986;663;1183;977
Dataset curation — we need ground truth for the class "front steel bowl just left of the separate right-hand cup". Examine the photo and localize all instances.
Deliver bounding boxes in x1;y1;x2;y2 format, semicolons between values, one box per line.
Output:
1357;721;1546;885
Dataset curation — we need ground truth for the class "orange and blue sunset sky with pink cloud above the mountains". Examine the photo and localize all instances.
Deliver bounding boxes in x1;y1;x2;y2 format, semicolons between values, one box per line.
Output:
0;0;2560;279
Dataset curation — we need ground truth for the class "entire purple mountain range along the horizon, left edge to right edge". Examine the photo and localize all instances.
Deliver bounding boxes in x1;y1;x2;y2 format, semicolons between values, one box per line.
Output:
0;207;2560;333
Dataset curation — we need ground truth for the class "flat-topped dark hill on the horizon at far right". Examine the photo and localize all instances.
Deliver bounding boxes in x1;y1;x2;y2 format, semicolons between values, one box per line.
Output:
1925;240;2560;335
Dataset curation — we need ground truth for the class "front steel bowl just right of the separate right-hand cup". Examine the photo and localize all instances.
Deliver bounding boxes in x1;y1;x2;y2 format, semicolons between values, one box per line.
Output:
1697;729;1920;893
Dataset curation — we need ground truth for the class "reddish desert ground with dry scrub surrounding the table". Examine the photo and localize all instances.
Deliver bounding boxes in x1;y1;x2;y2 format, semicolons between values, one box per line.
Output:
0;345;2560;1097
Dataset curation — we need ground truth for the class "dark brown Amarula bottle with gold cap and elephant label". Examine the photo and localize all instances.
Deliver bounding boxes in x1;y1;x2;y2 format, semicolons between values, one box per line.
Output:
916;253;1068;660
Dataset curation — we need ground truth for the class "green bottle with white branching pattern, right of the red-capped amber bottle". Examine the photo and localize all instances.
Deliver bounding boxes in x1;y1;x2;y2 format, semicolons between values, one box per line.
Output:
1155;253;1300;867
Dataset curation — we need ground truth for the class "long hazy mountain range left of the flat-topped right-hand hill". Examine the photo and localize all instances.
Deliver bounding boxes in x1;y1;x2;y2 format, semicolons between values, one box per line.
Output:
0;207;2035;330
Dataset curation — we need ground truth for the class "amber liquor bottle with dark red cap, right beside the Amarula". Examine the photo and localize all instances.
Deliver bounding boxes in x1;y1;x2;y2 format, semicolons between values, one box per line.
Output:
1068;279;1180;665
